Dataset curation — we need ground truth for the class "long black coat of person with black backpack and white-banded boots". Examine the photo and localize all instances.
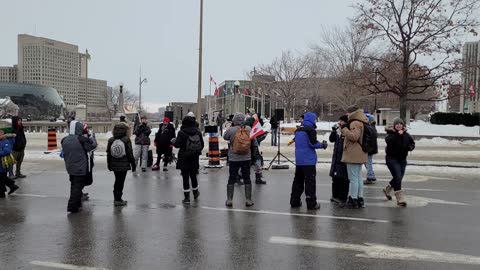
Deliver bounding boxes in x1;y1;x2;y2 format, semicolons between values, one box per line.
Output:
174;127;205;171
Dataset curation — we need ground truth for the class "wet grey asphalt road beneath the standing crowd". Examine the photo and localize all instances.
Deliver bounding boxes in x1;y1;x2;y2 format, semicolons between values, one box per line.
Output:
0;161;480;270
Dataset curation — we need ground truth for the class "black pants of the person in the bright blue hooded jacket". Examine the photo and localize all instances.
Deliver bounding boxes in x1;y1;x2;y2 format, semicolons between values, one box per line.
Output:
290;165;317;207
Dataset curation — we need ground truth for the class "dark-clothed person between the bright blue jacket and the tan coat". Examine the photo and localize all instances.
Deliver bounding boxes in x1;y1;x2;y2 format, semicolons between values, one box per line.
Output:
329;115;350;204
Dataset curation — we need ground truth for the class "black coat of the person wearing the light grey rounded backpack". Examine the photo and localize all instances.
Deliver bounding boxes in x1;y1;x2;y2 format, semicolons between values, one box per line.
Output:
107;124;135;172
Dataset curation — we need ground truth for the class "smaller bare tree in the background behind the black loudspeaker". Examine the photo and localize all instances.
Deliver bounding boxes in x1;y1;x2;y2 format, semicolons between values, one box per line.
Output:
258;51;312;119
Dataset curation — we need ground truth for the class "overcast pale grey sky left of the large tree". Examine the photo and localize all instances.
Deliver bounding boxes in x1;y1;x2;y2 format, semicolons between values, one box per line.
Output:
0;0;353;110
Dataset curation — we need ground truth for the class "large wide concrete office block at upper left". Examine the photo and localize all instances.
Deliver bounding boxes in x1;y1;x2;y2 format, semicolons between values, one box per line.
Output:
18;34;80;107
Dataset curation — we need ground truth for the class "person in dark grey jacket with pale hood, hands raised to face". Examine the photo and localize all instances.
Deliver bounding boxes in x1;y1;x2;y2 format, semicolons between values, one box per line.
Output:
61;121;97;213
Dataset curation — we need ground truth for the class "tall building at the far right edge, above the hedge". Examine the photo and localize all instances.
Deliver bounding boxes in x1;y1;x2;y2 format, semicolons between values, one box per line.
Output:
459;41;480;112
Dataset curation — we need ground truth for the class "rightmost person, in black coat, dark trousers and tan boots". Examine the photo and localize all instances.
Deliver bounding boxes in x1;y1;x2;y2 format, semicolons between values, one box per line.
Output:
383;118;415;206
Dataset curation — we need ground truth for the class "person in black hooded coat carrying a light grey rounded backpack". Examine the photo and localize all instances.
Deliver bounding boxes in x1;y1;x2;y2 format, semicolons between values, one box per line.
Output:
107;121;136;206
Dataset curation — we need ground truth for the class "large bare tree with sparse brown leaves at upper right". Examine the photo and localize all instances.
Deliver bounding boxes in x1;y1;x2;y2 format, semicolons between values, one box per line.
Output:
355;0;480;119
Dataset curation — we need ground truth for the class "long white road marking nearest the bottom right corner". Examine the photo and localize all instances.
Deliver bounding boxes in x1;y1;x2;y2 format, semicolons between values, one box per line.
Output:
269;236;480;265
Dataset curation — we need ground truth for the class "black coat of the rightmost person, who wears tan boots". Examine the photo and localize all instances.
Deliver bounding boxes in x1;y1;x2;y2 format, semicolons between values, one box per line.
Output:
385;129;415;160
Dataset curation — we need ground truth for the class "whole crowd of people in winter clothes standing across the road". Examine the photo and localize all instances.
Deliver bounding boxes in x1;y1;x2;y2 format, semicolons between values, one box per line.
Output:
0;107;415;213
